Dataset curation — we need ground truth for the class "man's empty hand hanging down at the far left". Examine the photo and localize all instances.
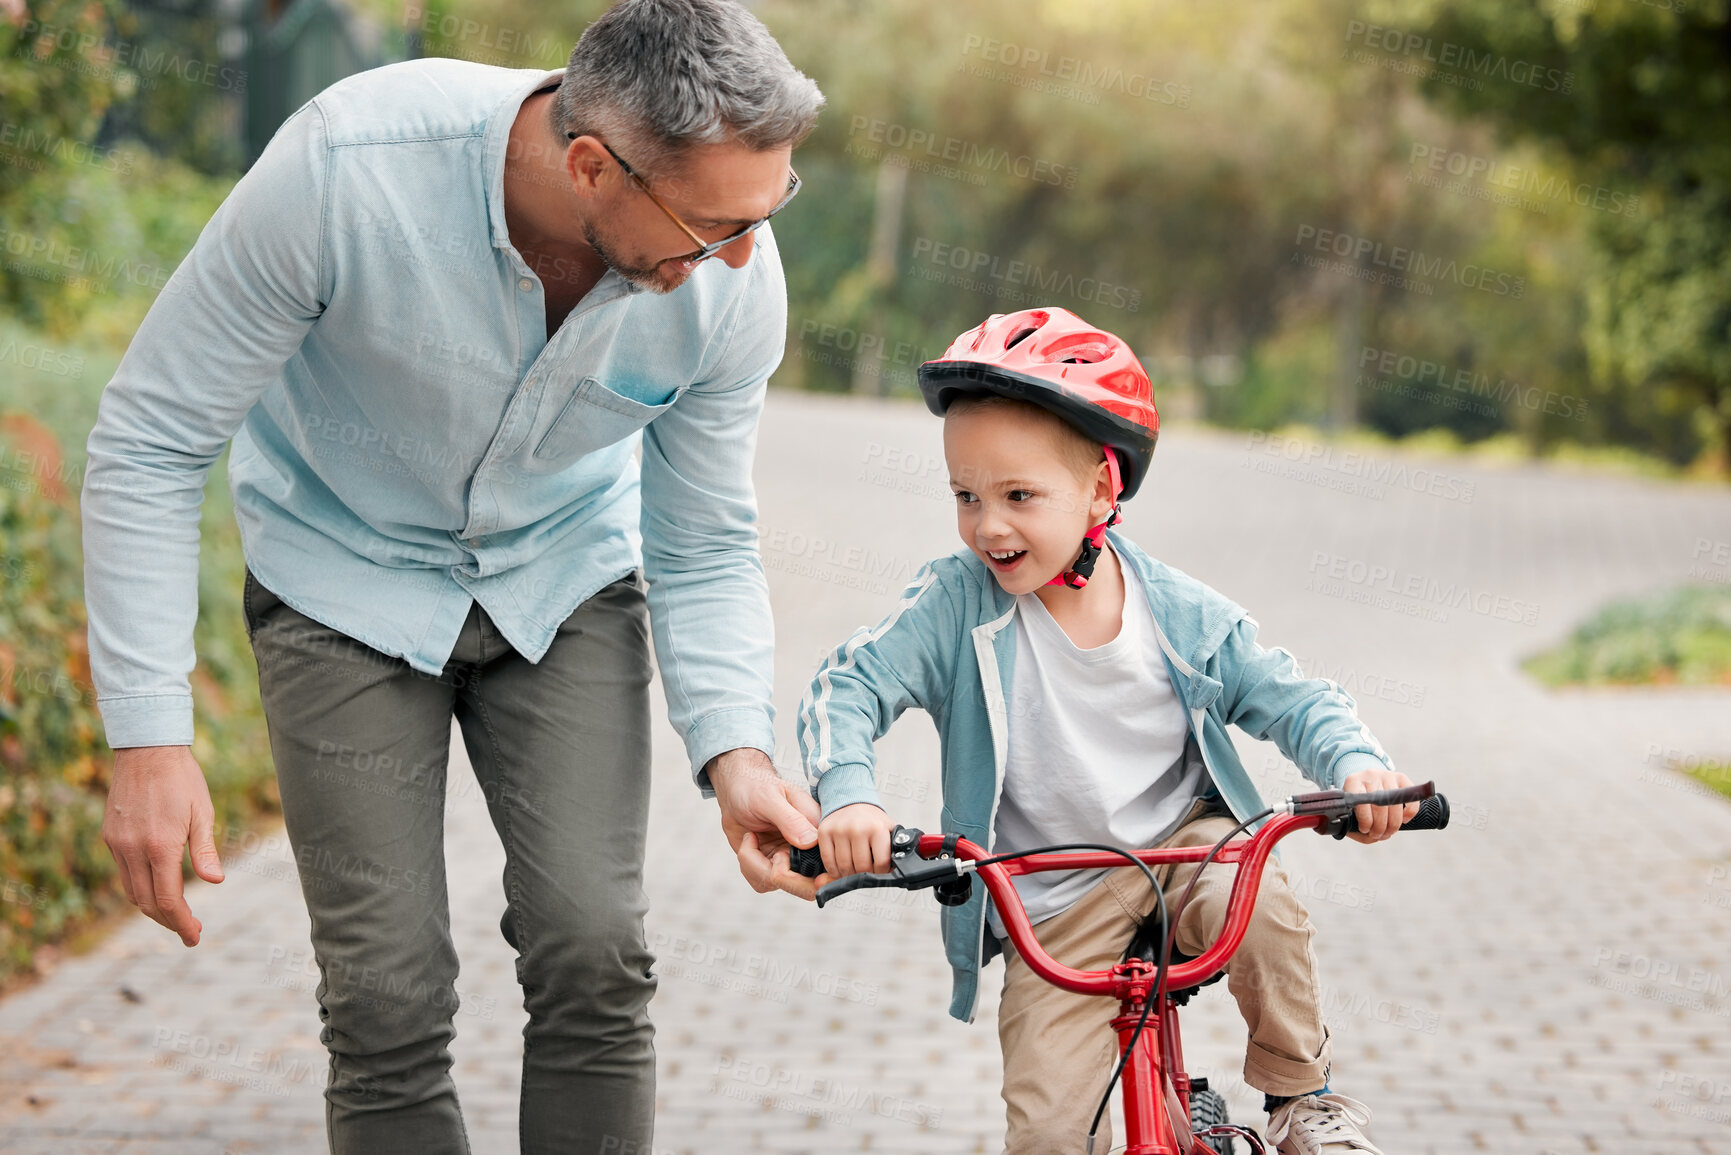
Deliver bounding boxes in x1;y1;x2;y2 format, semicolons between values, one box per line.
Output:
102;746;223;947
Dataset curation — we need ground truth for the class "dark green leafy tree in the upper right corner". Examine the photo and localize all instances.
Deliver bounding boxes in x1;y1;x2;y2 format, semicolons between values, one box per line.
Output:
1421;0;1731;464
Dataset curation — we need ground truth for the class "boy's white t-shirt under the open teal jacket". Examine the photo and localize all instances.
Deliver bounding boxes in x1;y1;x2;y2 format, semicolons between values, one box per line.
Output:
988;554;1208;939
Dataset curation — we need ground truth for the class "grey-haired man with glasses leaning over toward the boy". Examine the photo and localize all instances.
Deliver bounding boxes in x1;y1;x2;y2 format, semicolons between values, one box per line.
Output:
83;0;822;1155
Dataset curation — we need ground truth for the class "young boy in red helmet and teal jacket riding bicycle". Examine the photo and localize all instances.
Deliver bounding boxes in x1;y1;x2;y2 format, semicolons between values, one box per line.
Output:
798;308;1418;1155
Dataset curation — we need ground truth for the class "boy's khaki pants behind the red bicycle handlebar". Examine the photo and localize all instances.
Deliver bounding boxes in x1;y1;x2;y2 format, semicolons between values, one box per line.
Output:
997;802;1329;1155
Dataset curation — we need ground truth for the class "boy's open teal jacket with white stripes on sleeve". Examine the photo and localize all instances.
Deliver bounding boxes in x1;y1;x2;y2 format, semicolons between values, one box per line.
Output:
798;530;1393;1022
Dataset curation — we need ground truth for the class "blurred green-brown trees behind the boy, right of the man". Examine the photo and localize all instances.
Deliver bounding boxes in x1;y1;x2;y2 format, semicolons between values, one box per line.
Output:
756;0;1665;450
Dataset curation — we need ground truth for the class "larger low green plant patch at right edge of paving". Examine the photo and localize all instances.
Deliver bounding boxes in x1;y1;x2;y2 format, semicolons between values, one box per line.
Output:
1527;587;1731;686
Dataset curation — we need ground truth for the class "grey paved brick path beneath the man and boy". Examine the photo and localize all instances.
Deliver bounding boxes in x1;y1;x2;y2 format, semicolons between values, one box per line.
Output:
0;395;1731;1155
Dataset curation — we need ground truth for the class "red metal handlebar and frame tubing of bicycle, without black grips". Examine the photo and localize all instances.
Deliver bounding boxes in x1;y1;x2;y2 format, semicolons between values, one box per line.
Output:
917;814;1329;1155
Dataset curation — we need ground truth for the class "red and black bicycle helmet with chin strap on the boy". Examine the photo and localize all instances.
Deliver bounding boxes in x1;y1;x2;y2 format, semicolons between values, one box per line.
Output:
919;308;1160;589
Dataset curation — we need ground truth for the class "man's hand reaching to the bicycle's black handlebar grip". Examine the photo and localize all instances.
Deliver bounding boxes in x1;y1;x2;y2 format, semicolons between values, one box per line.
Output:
703;746;829;899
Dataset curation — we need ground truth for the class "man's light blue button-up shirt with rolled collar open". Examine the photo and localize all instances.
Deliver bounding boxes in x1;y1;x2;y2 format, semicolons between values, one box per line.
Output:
83;59;788;790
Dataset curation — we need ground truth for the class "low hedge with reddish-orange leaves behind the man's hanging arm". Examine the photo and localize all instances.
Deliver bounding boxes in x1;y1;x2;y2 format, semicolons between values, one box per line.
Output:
0;416;280;984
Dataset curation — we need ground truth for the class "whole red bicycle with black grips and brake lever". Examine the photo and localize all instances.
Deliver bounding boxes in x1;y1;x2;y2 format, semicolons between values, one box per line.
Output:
791;783;1449;1155
